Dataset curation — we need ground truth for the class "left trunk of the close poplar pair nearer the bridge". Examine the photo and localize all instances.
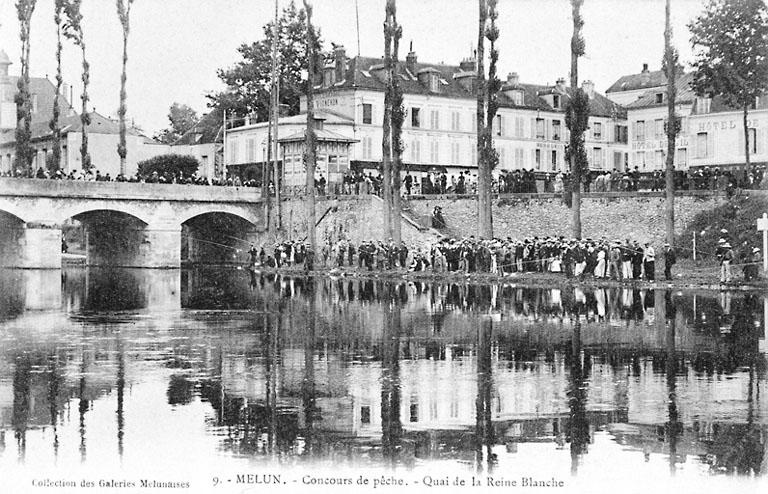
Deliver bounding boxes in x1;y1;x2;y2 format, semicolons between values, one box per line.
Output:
381;3;394;240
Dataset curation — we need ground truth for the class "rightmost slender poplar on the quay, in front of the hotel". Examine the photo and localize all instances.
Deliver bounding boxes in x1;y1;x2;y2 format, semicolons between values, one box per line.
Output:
664;0;678;248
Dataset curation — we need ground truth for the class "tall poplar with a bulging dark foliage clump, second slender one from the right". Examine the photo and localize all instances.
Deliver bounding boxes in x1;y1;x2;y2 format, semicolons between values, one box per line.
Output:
565;0;589;238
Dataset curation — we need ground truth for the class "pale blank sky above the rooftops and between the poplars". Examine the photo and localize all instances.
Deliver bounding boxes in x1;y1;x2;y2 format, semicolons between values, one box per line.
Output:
0;0;704;135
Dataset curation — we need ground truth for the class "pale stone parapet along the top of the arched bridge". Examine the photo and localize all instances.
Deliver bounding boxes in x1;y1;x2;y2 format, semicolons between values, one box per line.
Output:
0;178;261;202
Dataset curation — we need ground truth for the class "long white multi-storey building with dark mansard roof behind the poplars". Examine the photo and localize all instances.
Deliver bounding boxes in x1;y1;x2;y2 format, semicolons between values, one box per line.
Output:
227;46;627;183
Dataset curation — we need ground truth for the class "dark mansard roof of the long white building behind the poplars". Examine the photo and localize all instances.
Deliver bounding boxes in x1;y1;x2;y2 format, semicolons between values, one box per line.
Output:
317;56;626;117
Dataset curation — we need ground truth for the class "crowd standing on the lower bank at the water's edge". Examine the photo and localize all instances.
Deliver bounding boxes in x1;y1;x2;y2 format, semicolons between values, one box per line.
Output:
249;236;677;281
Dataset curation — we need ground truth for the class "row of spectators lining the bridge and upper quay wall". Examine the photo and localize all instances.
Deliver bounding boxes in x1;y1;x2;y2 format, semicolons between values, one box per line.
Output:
9;166;768;196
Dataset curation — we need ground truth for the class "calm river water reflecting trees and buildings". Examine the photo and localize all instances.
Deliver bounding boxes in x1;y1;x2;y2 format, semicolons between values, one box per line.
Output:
0;268;768;492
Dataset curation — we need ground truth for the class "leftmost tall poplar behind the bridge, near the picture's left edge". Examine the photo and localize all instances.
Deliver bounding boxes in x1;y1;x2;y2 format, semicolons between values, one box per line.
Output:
15;0;37;174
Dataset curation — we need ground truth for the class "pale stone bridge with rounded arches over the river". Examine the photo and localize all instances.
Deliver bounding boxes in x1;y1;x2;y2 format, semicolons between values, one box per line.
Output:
0;178;264;268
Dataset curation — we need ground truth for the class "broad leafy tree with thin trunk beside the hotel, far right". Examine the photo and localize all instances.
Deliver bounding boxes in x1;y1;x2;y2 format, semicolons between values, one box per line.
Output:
688;0;768;180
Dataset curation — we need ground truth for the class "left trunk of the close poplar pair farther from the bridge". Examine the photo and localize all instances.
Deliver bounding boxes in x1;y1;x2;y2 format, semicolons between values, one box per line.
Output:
476;0;493;238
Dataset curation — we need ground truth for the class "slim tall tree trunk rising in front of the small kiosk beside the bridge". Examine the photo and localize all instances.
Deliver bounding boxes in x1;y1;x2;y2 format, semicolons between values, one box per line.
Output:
304;0;317;253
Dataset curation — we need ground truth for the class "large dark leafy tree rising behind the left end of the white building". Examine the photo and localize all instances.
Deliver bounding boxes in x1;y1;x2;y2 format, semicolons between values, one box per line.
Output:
208;1;322;121
